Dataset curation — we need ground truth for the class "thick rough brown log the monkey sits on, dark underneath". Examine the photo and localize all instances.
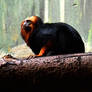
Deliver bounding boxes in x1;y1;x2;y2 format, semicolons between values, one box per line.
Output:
0;53;92;92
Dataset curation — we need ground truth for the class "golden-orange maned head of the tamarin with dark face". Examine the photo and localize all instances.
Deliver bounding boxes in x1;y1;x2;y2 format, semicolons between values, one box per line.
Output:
21;16;43;43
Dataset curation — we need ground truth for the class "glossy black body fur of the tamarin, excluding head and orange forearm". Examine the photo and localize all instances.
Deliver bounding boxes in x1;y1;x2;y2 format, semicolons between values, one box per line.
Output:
28;23;85;56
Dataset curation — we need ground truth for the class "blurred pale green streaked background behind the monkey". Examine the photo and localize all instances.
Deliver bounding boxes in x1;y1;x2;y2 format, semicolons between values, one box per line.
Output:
0;0;92;55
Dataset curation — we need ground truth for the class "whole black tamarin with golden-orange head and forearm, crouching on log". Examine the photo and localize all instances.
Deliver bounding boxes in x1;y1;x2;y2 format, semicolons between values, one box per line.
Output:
21;16;85;56
